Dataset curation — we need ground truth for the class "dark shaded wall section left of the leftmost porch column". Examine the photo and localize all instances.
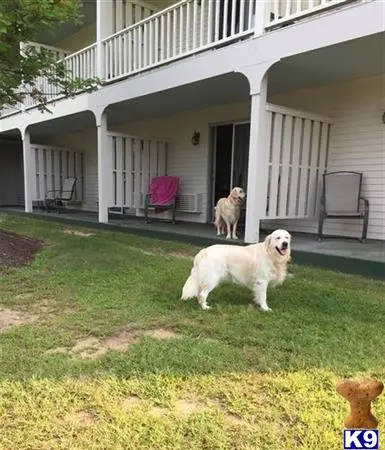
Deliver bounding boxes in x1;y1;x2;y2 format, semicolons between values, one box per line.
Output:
0;141;24;206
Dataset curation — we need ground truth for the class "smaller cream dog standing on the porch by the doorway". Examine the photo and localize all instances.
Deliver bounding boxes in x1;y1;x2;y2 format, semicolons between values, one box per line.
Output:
214;187;246;239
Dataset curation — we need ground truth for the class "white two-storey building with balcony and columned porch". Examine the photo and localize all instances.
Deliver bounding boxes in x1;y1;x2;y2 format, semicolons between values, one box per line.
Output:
0;0;385;242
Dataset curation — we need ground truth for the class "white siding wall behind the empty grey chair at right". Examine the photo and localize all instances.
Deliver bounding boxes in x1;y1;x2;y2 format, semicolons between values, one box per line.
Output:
263;76;385;240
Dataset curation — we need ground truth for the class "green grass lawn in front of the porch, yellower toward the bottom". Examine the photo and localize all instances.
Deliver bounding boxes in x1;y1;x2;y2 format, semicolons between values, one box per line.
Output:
0;215;385;450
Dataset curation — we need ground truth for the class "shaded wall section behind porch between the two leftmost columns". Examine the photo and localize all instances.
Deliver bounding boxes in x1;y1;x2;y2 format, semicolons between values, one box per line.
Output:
37;127;98;211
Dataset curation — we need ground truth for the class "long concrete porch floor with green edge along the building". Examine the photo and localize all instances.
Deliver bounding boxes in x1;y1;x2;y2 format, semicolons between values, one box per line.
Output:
0;208;385;278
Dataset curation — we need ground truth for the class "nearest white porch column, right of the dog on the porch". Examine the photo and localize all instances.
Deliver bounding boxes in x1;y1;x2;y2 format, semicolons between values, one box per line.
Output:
245;76;269;243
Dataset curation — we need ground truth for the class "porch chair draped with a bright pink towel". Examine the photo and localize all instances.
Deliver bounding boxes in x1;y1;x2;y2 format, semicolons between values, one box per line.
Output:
144;175;180;224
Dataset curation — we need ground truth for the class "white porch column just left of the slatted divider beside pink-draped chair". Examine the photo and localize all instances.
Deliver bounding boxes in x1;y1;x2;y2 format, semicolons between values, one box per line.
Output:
96;113;112;223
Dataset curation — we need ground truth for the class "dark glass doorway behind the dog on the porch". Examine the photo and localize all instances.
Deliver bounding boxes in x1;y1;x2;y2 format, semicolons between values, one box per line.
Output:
209;122;250;220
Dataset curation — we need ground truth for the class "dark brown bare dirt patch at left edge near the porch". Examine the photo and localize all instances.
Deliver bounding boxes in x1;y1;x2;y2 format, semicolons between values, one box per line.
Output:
0;230;43;268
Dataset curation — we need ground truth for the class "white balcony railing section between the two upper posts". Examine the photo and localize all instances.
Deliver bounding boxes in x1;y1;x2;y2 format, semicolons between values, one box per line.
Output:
103;0;258;81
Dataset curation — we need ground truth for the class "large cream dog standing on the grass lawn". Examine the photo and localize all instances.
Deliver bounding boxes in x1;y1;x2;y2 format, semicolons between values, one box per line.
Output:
181;230;291;311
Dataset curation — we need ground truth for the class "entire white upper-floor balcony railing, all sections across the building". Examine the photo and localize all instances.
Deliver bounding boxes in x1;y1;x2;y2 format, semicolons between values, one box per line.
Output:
0;0;356;116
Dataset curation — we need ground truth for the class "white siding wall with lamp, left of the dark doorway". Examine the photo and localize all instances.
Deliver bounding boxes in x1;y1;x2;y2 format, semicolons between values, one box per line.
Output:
112;102;250;223
